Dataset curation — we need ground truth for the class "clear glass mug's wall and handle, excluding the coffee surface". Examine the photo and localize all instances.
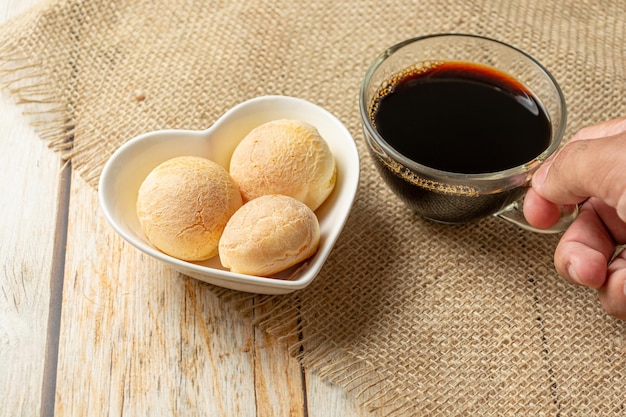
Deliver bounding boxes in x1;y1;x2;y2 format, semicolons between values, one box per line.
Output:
359;34;578;233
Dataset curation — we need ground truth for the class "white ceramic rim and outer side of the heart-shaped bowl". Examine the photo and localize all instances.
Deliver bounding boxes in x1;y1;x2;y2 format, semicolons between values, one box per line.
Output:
98;95;360;294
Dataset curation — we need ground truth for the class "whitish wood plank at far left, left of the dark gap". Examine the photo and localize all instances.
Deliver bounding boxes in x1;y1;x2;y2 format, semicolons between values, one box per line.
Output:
0;0;61;416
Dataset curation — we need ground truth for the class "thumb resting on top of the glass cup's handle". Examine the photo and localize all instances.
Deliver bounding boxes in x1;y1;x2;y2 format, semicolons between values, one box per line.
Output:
532;123;626;221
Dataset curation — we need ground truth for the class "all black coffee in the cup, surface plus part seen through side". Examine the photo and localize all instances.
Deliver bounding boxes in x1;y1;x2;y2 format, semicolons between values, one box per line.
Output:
370;62;551;223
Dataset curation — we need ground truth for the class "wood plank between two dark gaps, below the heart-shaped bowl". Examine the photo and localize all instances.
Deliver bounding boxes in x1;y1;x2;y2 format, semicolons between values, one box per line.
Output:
56;171;303;417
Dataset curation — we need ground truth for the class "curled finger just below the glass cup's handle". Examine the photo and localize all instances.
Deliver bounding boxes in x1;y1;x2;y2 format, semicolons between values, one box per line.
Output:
554;199;615;288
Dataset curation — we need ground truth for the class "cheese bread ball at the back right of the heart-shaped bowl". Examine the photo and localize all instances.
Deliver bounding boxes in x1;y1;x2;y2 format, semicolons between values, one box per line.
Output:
230;119;337;211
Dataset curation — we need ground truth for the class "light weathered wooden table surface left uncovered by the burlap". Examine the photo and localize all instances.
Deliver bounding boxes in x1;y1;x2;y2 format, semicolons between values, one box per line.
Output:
0;0;368;417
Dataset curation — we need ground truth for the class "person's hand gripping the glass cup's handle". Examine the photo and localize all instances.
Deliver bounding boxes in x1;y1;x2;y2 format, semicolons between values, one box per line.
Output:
524;117;626;320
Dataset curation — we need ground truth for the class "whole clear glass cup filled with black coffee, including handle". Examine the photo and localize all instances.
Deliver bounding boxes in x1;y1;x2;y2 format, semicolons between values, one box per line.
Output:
359;34;577;233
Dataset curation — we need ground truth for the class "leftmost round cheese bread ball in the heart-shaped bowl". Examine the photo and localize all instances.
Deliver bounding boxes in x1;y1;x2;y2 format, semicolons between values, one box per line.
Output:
137;156;242;261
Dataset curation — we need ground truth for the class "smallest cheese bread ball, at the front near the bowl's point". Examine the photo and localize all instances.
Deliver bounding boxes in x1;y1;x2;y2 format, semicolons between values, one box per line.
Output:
219;194;320;276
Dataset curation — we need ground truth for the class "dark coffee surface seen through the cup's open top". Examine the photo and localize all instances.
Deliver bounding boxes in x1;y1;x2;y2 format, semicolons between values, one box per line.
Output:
372;62;550;174
